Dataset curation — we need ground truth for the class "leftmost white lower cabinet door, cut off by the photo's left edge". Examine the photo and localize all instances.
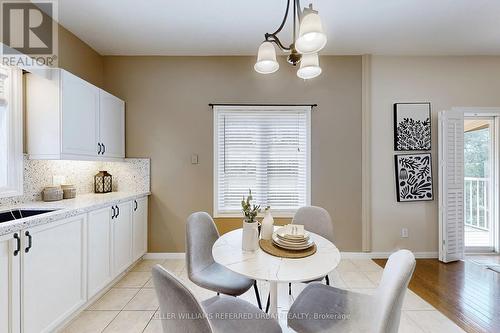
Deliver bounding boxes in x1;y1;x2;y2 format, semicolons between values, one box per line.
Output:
0;232;21;333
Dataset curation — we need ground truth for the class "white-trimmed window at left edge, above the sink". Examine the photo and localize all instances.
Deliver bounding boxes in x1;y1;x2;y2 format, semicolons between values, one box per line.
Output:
0;65;23;198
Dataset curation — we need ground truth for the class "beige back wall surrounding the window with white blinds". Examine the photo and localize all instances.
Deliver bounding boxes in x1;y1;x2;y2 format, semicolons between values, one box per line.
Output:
104;56;361;252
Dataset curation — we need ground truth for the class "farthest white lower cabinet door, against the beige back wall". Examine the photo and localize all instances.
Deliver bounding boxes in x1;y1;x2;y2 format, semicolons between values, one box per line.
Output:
132;197;148;261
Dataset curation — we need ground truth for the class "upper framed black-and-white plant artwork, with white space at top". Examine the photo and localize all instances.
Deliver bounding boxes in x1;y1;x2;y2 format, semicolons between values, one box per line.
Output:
394;103;431;151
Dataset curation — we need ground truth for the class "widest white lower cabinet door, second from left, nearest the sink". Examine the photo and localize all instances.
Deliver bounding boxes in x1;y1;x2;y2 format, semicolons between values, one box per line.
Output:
21;215;87;333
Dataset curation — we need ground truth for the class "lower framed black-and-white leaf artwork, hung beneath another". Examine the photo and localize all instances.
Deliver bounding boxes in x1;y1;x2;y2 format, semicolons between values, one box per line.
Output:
394;154;433;202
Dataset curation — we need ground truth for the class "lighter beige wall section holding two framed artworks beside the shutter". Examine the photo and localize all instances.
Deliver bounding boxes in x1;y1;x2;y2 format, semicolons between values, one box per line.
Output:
371;56;500;252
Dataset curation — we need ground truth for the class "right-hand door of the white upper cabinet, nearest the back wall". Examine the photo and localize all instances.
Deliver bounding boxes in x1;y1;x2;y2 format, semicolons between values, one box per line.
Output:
98;90;125;158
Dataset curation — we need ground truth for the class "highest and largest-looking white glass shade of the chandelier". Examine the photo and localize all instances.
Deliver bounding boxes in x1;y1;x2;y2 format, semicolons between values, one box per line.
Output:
295;9;327;54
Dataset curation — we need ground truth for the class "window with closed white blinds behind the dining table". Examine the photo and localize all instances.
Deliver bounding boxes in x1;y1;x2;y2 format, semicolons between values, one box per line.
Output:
214;106;311;217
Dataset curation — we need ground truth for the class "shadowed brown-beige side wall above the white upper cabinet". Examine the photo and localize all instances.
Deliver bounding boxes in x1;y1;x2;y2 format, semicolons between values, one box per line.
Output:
58;26;103;87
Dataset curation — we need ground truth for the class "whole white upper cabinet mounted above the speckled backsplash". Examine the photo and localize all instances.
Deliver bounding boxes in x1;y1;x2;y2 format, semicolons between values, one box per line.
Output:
26;69;125;160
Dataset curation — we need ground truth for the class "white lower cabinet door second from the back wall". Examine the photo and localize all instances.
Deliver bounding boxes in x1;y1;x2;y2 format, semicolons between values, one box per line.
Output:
111;202;132;276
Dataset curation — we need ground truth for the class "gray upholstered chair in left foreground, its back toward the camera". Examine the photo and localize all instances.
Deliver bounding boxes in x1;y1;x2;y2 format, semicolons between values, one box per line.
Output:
153;265;281;333
